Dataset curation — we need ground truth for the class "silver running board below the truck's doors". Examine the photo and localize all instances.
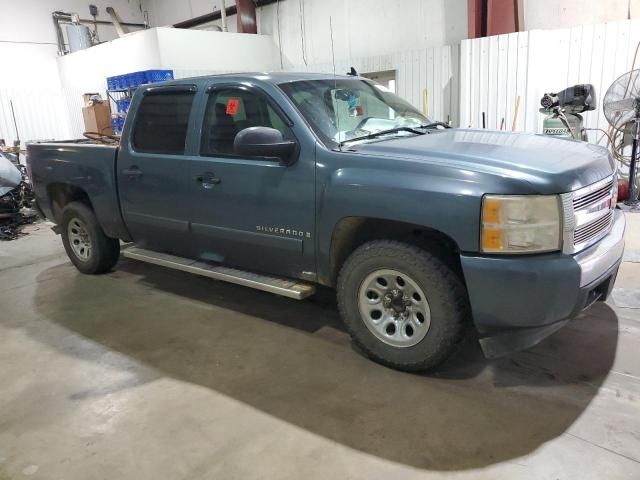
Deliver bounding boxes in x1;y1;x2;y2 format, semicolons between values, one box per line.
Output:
122;247;316;300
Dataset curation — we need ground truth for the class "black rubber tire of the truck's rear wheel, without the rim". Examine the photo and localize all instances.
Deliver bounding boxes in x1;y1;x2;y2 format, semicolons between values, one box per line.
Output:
60;202;120;275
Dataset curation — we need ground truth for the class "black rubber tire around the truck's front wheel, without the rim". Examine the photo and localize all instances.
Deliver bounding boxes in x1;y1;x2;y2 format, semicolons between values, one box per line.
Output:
337;240;469;372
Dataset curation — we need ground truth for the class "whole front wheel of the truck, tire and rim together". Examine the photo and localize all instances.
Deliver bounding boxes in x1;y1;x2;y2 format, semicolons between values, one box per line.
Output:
338;240;469;371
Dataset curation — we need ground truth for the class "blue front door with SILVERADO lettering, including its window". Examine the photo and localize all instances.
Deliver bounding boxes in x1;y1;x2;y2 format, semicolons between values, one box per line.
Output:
190;85;315;278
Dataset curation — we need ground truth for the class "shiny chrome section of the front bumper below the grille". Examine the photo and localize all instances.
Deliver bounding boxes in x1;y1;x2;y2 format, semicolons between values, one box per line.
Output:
574;210;625;287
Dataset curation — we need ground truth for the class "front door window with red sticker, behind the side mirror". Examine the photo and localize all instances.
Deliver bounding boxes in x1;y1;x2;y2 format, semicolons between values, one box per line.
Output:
200;88;293;156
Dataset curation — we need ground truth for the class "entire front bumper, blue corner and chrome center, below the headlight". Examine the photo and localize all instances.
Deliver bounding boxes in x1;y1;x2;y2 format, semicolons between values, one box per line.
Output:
460;210;625;357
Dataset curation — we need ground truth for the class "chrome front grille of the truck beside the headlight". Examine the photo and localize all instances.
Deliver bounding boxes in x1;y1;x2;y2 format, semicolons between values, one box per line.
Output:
560;175;618;254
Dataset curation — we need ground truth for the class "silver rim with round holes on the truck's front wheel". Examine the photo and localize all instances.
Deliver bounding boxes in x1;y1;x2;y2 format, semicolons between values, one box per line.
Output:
358;269;431;348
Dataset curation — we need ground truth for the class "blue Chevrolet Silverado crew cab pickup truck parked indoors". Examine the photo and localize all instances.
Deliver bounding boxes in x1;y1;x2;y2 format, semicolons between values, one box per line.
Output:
28;73;625;371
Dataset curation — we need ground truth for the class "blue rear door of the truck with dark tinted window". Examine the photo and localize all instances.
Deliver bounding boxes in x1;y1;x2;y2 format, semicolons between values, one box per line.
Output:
117;85;196;256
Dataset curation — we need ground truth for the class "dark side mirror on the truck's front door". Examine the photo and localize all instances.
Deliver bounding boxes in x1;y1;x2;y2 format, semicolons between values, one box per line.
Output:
233;127;298;165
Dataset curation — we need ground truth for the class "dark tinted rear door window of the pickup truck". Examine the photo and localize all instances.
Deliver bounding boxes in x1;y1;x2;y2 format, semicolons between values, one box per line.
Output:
133;91;194;155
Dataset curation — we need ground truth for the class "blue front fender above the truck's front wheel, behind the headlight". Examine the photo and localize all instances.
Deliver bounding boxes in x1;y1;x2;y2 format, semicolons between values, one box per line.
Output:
317;153;486;282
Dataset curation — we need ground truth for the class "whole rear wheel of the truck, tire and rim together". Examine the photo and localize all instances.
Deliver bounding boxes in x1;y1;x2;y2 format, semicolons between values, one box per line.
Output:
61;202;120;274
